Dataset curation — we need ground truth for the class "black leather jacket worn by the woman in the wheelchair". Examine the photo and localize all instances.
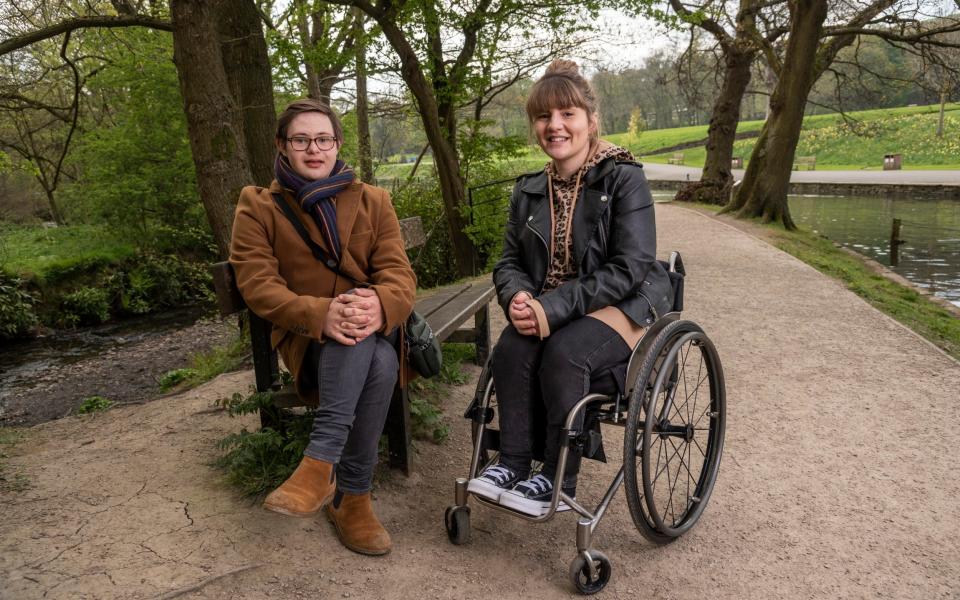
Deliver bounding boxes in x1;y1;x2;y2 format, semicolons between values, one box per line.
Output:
493;157;673;331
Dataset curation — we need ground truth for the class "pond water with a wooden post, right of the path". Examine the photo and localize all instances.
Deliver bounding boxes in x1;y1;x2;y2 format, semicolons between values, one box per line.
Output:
789;196;960;306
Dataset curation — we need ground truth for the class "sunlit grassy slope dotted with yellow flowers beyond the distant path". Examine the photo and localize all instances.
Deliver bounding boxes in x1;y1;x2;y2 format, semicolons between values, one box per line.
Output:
632;104;960;170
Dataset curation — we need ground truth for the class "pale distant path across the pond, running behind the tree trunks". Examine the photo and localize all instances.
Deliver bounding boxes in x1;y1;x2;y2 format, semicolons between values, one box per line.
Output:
643;162;960;186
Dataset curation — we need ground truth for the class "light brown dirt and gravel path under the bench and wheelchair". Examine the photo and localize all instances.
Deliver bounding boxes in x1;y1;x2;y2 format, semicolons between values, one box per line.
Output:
0;205;960;599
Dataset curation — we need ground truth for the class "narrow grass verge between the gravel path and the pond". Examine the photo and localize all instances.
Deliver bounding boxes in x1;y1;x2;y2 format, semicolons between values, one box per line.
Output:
765;216;960;360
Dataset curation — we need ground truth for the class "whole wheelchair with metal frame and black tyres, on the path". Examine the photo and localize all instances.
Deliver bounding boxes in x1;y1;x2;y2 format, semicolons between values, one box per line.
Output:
444;252;726;594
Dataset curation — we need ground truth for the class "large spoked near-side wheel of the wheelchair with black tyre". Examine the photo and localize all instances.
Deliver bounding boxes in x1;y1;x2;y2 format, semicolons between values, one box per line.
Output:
623;321;726;544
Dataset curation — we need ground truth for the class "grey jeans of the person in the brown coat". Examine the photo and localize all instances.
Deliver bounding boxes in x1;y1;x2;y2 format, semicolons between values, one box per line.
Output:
303;335;398;494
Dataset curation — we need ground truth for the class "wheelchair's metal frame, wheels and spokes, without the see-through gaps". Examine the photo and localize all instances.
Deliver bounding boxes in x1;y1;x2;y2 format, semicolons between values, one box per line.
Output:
444;252;726;594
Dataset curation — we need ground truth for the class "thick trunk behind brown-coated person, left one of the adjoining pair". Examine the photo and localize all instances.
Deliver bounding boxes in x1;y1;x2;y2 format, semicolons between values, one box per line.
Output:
170;0;255;258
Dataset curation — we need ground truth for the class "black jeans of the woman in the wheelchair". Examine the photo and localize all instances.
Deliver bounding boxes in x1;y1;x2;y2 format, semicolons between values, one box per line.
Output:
492;317;632;488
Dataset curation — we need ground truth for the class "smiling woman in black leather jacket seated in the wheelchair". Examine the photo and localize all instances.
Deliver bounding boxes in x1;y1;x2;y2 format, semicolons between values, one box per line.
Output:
467;60;673;516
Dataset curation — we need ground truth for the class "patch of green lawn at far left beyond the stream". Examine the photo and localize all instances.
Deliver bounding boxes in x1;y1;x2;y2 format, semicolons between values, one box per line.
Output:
0;225;136;280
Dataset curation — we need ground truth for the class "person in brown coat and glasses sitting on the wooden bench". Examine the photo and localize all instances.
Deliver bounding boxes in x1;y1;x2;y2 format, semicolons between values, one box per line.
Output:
230;100;416;554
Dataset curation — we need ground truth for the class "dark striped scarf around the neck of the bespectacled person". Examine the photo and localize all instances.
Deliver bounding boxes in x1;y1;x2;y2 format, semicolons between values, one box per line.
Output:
273;152;354;263
